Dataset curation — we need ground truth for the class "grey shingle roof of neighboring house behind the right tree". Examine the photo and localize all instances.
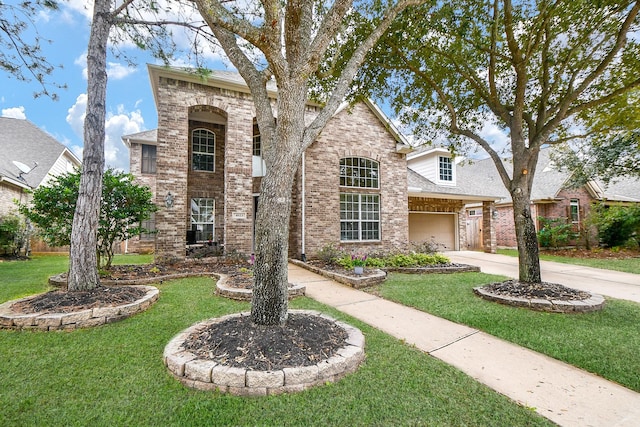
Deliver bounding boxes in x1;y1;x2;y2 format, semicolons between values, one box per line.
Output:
457;148;640;203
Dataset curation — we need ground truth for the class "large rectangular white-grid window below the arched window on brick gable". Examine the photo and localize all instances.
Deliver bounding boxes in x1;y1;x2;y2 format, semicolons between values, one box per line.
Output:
340;193;380;242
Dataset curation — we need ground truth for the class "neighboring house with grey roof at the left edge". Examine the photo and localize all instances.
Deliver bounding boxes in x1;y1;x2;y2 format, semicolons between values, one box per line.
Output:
0;117;81;215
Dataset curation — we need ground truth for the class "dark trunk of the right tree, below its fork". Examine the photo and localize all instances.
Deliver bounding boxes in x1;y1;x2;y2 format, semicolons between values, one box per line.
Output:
511;185;541;283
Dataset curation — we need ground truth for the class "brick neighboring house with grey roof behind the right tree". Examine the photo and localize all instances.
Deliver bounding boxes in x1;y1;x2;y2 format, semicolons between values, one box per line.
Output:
458;148;640;247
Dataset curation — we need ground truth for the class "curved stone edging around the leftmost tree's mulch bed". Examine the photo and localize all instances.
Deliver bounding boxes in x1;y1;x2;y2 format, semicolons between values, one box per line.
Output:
0;286;160;331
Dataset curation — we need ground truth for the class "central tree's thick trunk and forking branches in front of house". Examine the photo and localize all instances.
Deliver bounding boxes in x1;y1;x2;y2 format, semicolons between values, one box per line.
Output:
195;0;421;325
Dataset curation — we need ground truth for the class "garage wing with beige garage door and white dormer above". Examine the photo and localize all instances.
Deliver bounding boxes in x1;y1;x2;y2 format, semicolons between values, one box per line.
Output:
407;147;500;252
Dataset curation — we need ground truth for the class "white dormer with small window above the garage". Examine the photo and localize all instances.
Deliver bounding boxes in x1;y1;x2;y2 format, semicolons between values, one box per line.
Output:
407;148;456;186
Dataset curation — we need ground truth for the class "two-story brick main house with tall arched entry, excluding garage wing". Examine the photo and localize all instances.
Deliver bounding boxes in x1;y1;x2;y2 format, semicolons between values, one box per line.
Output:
122;66;409;259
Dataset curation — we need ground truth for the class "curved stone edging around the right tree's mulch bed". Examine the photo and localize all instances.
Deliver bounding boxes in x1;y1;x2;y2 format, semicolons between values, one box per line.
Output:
473;286;605;313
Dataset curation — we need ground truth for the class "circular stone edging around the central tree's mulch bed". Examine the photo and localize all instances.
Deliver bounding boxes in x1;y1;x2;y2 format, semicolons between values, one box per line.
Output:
163;310;365;396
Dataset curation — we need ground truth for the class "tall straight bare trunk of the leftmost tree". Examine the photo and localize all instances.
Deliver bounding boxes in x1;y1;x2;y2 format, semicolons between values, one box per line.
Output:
68;0;111;291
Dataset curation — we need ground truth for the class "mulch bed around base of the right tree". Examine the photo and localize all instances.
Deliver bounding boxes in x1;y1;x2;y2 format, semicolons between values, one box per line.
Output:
482;280;591;301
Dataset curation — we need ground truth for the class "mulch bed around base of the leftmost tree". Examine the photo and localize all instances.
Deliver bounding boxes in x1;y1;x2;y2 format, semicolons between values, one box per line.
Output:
11;286;147;314
